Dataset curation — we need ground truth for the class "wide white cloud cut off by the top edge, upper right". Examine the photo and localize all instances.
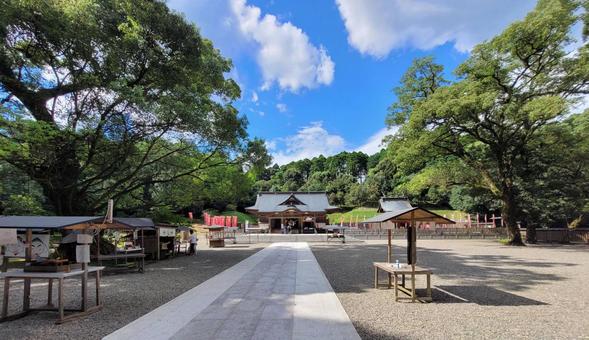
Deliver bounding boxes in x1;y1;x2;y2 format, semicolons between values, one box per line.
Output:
336;0;536;58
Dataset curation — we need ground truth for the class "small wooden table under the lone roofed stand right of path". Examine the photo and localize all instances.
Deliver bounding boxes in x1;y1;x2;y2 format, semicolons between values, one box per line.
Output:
373;262;432;302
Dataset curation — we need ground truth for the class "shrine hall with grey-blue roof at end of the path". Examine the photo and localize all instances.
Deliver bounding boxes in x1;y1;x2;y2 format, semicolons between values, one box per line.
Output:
246;191;339;234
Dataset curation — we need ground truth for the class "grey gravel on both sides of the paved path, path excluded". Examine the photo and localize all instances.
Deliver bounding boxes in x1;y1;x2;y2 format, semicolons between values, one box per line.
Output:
0;240;589;340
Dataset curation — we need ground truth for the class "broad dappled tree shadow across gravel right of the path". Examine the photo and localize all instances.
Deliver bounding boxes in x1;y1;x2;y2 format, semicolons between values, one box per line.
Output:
312;245;575;296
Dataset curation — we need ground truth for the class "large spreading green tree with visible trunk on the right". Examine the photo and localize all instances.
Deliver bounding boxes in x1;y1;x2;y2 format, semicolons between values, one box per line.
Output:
388;0;589;245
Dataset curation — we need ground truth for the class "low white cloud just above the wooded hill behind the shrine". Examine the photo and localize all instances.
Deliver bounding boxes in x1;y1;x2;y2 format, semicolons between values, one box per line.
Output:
266;122;346;165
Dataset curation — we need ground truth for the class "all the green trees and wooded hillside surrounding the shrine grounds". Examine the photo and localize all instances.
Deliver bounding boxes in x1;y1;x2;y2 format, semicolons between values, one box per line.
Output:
0;0;589;244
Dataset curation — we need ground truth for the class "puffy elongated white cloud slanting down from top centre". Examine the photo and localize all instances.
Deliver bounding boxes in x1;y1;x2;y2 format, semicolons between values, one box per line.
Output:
231;0;335;92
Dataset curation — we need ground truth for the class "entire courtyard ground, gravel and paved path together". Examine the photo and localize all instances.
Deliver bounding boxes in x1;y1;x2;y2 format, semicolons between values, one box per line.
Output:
0;240;589;339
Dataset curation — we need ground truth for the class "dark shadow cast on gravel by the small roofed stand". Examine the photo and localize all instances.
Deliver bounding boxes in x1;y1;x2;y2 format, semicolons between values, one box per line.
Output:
433;286;547;306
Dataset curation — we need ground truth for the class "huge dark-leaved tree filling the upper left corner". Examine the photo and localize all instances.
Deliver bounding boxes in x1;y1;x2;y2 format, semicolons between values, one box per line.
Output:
0;0;246;215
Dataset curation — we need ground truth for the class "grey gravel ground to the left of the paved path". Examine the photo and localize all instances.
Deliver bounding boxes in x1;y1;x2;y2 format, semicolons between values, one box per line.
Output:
0;245;263;340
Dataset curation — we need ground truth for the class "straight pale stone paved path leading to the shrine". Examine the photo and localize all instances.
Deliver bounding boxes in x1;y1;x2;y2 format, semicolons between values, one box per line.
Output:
105;243;359;340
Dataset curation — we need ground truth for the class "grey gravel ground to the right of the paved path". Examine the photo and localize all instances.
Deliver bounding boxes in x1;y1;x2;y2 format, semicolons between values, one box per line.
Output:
312;240;589;339
